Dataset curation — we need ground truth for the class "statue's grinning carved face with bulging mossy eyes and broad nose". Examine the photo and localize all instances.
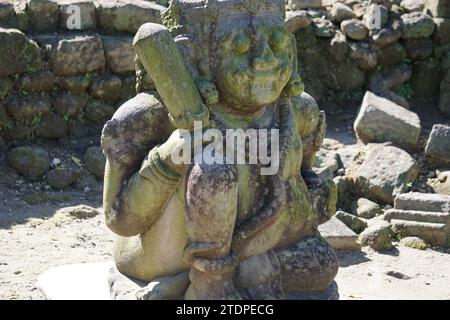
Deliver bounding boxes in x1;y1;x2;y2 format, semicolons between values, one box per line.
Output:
213;13;296;113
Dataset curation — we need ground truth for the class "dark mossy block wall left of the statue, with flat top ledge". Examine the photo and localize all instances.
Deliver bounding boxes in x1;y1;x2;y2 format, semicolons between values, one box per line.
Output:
0;0;167;141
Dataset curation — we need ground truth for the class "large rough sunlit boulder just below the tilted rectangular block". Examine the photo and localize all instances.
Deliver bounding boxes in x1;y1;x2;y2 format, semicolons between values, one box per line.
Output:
354;145;419;203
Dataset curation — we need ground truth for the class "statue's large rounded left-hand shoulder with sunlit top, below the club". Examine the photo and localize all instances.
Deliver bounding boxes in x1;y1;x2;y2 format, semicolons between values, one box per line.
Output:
101;93;174;163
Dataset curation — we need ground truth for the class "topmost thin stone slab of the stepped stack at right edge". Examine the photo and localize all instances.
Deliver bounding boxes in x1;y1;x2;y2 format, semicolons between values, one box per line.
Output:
394;192;450;212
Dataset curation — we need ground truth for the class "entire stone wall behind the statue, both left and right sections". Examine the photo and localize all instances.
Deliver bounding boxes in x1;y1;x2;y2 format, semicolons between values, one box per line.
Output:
0;0;450;141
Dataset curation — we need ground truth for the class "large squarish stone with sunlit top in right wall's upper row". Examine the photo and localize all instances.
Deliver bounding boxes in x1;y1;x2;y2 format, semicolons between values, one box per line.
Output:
401;12;434;39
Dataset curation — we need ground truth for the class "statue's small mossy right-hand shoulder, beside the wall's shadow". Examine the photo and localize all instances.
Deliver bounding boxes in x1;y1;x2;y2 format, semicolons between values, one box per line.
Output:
290;92;320;137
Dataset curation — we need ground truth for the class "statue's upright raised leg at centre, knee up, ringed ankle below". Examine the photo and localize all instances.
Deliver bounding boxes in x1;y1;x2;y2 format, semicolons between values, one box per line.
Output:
184;164;238;299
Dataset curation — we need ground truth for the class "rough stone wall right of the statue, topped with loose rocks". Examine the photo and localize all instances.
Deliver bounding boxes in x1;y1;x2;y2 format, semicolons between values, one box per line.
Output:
287;0;450;114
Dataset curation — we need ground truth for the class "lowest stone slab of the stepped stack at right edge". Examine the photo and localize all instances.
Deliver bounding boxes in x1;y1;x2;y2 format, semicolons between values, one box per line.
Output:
391;219;450;246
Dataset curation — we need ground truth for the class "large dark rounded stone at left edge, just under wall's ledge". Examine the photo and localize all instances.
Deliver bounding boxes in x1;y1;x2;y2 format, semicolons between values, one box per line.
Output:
0;28;43;76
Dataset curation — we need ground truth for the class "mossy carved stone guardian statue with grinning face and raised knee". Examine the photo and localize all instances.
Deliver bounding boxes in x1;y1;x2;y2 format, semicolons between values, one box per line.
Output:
102;0;338;299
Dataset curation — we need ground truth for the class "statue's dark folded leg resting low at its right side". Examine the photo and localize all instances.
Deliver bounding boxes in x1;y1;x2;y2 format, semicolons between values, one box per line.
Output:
275;235;339;294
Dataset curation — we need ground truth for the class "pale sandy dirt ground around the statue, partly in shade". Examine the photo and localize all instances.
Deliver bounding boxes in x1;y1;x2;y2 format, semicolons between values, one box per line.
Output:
0;100;450;300
